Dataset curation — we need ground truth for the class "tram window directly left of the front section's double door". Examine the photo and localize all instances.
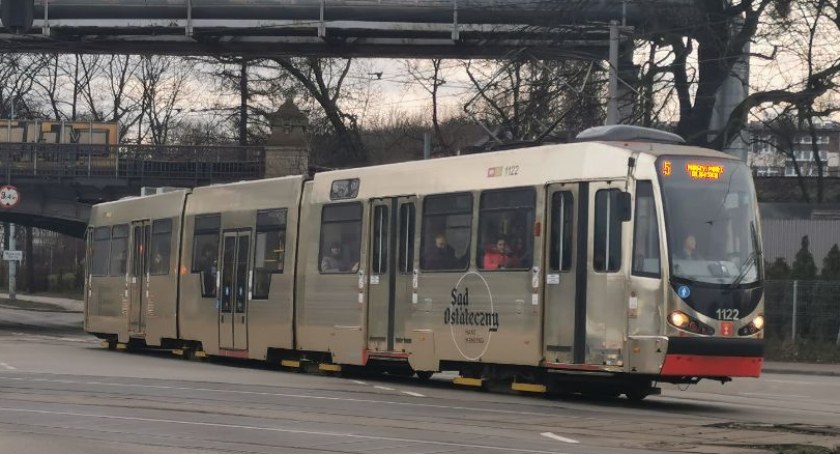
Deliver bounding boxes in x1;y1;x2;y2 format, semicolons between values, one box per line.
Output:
318;203;362;274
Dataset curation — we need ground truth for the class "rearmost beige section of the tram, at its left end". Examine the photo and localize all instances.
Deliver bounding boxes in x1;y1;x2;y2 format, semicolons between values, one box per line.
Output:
85;190;188;346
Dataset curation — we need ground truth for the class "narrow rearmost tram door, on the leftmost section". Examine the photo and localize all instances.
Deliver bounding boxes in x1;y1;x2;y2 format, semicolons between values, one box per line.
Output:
128;221;152;336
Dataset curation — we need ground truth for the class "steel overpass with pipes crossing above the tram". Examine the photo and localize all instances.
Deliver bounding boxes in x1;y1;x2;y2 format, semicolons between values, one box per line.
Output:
0;0;697;58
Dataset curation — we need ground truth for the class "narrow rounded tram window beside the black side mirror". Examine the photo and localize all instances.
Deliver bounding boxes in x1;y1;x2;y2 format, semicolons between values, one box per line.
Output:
592;189;622;273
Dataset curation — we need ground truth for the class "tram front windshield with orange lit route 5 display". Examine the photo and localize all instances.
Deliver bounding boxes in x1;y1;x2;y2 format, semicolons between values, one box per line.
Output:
657;156;761;285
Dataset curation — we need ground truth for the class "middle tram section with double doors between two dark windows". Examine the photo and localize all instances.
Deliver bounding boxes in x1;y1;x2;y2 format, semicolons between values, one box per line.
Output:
180;177;302;359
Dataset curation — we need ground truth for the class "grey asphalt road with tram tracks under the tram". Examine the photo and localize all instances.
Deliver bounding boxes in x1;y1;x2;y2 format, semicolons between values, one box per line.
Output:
0;309;840;454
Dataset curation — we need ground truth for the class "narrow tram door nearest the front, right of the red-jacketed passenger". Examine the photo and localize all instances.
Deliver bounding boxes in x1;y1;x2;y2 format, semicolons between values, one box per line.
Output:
543;183;588;363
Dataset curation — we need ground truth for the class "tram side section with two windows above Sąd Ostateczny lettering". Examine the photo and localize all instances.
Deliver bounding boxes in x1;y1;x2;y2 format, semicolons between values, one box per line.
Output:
408;187;544;370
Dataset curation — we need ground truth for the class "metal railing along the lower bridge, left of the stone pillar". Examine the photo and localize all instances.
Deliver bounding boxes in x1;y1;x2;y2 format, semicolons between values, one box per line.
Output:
0;143;265;185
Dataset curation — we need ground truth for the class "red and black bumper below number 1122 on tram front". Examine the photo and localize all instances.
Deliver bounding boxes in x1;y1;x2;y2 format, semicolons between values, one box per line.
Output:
659;337;764;377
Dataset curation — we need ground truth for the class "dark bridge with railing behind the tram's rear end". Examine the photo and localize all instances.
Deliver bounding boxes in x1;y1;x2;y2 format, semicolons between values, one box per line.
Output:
0;143;267;238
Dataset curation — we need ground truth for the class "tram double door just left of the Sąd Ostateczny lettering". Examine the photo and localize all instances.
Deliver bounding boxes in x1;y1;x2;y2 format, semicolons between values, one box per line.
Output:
367;197;416;354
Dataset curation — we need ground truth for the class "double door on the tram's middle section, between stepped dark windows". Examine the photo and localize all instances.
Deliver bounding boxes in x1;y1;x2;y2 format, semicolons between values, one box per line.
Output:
219;231;251;350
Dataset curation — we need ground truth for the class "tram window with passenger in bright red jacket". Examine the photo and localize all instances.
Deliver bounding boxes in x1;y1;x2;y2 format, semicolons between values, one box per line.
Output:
476;188;536;270
